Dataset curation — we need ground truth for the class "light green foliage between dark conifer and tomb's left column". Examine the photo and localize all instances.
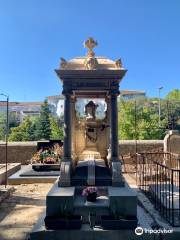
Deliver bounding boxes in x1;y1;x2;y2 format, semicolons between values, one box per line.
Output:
50;116;63;139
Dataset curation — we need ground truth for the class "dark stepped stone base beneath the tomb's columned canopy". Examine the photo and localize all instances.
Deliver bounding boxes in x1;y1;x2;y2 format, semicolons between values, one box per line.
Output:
30;182;139;240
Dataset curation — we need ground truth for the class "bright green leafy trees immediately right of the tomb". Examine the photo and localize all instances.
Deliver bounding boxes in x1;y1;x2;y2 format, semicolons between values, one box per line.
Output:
118;99;167;140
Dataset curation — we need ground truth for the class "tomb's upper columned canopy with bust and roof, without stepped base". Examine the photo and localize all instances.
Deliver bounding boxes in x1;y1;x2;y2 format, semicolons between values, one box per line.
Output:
56;38;126;186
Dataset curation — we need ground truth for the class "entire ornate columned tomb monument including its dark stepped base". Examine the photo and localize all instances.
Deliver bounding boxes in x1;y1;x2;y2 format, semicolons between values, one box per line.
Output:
31;38;137;240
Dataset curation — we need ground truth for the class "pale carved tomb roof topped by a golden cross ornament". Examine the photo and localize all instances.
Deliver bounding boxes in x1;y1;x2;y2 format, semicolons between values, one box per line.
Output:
60;38;124;70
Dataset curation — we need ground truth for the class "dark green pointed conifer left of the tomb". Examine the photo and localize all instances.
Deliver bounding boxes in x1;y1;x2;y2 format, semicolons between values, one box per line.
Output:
36;100;51;140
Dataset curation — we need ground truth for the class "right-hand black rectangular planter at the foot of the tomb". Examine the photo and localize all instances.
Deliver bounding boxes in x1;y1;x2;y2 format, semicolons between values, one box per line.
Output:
101;205;137;230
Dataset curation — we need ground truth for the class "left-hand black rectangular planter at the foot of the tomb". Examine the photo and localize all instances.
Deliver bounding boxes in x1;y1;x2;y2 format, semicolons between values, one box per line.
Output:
44;205;82;230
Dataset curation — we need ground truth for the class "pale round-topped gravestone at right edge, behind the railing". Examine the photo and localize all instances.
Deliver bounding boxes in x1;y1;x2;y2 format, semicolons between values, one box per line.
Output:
164;130;180;154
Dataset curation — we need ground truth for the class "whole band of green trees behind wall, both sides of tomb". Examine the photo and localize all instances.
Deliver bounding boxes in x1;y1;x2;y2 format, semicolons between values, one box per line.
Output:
4;89;180;141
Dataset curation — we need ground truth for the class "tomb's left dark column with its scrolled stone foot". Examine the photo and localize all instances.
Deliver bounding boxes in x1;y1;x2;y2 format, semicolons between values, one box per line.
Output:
58;92;72;187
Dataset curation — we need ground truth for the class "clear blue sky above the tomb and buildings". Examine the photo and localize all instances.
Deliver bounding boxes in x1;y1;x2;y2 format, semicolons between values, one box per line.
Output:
0;0;180;101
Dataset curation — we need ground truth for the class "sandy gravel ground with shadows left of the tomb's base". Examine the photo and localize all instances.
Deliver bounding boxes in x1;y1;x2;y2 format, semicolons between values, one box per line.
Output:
0;183;52;240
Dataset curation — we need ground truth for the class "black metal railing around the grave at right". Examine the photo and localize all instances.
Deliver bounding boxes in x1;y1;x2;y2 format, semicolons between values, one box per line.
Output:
136;152;180;226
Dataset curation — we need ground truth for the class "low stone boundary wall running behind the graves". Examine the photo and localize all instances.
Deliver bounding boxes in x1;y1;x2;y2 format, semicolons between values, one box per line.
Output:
0;140;163;164
